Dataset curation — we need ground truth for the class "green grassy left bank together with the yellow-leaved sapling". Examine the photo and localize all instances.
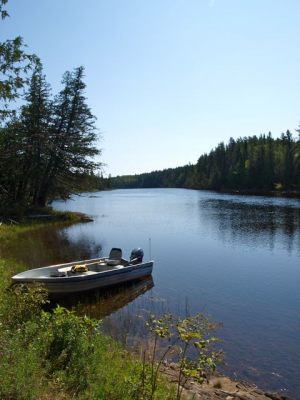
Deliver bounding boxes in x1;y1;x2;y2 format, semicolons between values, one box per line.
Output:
0;220;224;400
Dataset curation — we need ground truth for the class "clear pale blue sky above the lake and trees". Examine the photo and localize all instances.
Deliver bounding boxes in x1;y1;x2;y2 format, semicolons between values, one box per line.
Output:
0;0;300;176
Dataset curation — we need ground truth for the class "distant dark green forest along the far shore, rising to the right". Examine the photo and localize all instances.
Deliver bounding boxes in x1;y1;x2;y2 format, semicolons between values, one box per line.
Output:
110;131;300;191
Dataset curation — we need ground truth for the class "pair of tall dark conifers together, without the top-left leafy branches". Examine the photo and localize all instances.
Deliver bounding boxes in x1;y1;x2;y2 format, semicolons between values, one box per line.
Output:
0;65;100;208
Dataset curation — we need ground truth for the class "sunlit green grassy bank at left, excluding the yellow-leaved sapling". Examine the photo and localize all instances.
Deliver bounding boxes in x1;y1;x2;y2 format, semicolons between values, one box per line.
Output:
0;220;174;400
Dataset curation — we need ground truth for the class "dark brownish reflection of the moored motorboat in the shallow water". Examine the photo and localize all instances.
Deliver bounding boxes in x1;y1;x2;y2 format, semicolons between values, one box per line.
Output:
59;275;154;319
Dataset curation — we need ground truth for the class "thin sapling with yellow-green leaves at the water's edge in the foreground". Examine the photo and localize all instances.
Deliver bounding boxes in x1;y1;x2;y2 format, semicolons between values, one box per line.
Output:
146;313;222;400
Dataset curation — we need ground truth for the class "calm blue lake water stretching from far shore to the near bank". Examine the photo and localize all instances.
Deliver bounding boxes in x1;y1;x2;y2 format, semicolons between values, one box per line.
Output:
4;189;300;398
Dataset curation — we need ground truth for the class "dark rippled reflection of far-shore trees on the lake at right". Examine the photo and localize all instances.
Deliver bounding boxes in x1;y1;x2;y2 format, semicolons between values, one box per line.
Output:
199;198;300;253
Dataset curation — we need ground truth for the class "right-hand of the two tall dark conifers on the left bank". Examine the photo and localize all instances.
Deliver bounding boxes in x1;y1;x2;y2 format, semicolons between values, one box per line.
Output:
35;67;101;206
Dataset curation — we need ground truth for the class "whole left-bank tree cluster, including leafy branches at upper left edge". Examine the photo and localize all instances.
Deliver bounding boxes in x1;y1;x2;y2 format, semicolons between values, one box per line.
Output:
0;0;103;211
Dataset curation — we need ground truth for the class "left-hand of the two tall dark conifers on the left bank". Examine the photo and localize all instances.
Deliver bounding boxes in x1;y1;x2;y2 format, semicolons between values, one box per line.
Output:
0;65;51;204
